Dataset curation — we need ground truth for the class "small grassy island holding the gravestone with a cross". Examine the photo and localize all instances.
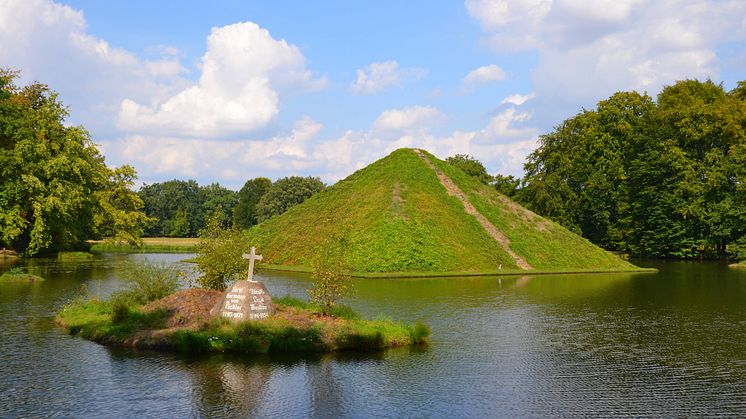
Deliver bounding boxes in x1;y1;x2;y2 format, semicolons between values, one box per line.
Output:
55;253;430;353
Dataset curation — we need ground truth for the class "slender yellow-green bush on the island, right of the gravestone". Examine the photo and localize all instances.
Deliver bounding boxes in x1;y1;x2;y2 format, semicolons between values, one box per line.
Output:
308;237;351;314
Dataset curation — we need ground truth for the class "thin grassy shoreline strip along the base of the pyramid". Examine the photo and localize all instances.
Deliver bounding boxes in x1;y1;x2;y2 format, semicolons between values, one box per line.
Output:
258;264;658;278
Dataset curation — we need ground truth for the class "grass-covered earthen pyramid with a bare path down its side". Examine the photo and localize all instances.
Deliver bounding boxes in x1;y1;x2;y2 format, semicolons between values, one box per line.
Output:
248;149;635;273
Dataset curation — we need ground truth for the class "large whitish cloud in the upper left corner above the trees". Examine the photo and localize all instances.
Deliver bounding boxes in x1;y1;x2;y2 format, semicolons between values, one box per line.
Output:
0;0;186;134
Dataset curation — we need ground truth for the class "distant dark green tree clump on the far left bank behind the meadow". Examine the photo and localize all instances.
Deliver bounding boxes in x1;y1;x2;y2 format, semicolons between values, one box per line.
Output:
137;180;238;237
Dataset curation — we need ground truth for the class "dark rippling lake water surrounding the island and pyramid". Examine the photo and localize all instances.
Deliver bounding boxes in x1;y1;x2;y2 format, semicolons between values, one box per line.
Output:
0;255;746;417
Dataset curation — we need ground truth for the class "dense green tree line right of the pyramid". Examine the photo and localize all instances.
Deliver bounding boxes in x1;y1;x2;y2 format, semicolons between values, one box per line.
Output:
448;80;746;260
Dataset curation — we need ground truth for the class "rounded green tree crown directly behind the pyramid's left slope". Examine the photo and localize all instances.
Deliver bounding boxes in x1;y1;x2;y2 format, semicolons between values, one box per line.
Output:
256;176;325;222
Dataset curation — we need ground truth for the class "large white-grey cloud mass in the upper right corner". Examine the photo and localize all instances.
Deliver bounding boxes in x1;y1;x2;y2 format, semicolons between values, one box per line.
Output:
465;0;746;108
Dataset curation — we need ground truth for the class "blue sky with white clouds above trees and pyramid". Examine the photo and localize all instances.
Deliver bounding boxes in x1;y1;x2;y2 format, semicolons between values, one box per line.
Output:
0;0;746;190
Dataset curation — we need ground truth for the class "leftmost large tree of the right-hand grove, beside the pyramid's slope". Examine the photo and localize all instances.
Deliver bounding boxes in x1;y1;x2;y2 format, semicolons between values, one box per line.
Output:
517;92;654;244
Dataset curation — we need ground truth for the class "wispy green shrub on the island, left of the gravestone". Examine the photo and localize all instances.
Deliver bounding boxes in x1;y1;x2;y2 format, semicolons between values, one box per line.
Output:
111;261;184;306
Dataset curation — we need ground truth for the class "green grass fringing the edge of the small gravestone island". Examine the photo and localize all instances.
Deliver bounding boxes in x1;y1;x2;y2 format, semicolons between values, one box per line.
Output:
56;297;430;353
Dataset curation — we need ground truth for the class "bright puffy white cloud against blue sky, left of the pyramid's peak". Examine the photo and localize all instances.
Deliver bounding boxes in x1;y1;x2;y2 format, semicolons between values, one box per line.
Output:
117;22;319;138
